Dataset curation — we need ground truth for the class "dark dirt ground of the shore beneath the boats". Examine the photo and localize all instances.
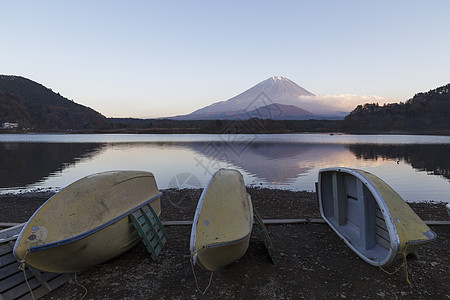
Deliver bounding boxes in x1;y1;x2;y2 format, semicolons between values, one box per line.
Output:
0;188;450;299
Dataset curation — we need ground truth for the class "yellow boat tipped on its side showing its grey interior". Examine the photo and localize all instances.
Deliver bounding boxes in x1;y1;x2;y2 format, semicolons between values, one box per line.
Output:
318;167;436;266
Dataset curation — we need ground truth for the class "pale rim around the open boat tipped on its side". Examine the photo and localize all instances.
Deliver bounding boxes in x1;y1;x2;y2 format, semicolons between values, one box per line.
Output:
318;167;401;266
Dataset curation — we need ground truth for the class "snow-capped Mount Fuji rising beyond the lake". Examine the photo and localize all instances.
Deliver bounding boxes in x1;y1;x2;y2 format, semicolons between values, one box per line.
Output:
171;76;348;120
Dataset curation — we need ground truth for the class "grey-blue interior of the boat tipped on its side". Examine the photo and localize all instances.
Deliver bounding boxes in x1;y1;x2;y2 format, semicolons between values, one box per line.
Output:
321;171;390;263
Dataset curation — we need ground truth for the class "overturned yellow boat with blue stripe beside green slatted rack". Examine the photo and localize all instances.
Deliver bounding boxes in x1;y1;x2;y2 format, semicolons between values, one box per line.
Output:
14;171;161;273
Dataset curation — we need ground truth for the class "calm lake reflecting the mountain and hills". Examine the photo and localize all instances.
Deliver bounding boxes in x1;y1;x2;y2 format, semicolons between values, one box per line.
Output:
0;134;450;202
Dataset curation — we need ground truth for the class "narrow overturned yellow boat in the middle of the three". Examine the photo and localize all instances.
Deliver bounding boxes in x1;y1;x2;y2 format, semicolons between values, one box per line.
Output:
190;169;253;271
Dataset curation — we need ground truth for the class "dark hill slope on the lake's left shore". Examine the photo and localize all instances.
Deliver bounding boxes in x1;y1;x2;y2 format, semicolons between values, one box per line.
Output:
0;75;106;129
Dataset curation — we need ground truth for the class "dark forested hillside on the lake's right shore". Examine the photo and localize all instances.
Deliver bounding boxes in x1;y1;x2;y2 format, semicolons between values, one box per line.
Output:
342;84;450;133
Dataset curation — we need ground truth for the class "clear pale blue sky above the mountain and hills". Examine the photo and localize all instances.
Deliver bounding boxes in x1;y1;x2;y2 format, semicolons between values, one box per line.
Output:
0;0;450;117
